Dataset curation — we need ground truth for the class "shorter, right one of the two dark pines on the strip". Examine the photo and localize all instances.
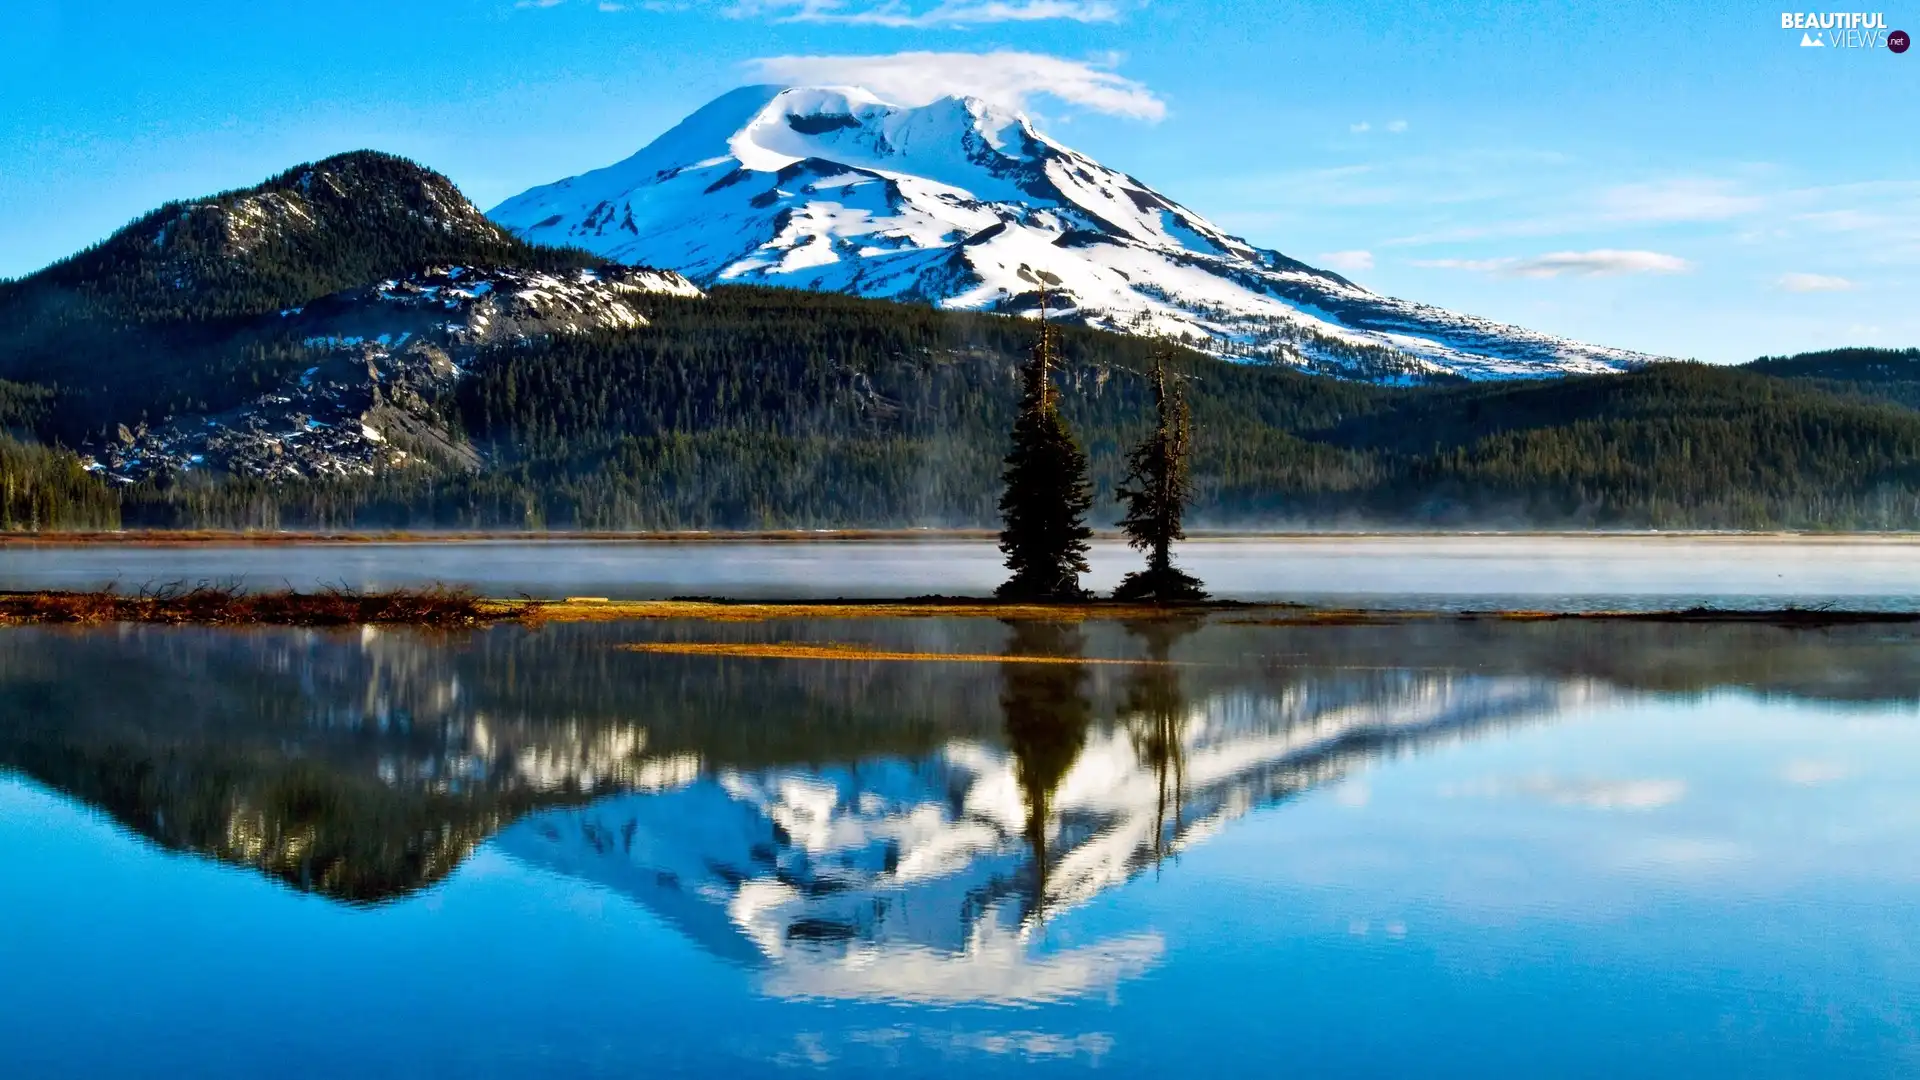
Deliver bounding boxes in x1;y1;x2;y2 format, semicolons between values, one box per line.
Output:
1114;348;1206;600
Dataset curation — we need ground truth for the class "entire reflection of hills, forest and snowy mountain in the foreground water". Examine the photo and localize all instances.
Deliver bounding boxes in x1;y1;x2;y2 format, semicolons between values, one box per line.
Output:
0;617;1920;1003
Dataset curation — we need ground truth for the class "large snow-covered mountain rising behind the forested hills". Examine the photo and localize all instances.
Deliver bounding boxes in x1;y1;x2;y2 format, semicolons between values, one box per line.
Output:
490;86;1657;379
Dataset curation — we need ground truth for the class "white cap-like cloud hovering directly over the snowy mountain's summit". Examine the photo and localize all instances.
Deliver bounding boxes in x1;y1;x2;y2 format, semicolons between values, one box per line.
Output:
749;50;1167;121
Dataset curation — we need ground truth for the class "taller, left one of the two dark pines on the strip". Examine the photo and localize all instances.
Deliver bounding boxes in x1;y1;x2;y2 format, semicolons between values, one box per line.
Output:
996;282;1092;600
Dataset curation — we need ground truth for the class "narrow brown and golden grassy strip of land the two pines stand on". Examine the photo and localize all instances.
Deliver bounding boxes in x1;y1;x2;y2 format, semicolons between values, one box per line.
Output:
0;586;1920;628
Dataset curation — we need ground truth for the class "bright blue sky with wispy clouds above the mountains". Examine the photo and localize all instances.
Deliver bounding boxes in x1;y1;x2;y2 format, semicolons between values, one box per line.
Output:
0;0;1920;361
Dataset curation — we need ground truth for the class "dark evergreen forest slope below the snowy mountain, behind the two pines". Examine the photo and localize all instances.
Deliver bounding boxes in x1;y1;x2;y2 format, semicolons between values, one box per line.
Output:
74;288;1920;528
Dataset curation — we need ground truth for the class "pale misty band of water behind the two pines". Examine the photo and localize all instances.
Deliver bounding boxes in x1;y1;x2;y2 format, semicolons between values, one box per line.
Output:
11;536;1920;609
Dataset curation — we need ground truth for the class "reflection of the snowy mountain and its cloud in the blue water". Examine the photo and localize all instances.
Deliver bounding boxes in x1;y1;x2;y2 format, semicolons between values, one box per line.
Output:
495;623;1590;1003
